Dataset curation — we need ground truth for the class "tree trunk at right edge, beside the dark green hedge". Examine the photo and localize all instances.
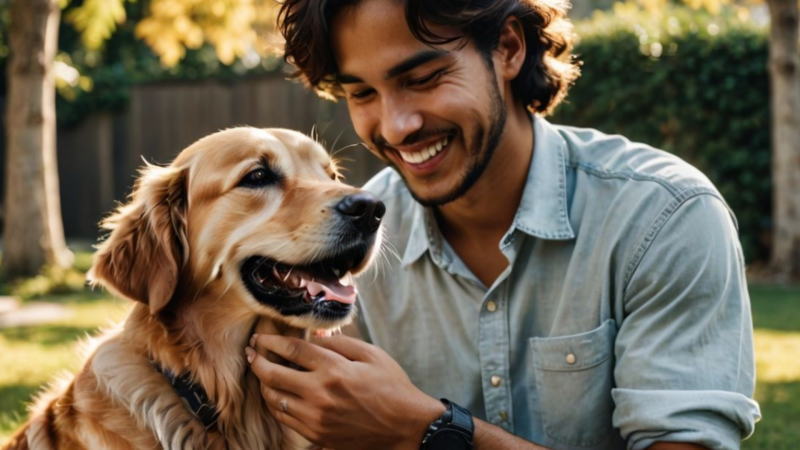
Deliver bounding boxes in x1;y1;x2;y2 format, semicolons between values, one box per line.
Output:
767;0;800;281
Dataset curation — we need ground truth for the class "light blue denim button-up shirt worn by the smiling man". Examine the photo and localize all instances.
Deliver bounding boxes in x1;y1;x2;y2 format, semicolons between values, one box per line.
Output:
358;117;760;449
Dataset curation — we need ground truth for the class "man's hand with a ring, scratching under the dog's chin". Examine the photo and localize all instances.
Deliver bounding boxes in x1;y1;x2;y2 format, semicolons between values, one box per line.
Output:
245;335;445;449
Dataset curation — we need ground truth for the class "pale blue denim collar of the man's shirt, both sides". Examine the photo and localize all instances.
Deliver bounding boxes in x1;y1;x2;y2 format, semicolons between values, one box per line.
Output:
402;116;575;267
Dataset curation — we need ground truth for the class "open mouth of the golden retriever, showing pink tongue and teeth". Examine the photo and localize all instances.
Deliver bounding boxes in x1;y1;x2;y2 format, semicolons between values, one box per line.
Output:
241;247;367;321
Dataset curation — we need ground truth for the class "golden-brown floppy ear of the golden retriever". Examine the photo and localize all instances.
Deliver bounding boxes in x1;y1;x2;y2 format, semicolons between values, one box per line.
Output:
88;165;189;314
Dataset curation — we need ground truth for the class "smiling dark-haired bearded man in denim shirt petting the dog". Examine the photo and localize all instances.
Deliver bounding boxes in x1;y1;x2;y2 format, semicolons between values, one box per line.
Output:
247;0;759;449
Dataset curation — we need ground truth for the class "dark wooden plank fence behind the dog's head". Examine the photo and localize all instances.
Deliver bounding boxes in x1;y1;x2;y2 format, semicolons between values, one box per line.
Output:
0;76;382;240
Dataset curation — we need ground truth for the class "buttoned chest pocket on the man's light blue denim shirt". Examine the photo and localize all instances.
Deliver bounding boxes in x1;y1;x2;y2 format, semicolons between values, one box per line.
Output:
529;319;617;448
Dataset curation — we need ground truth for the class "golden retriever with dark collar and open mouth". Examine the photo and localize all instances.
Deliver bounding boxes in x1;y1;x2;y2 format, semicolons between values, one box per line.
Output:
4;127;384;450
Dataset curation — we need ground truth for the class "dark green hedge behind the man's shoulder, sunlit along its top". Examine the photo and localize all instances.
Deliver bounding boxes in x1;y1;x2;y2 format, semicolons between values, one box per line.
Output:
554;5;771;261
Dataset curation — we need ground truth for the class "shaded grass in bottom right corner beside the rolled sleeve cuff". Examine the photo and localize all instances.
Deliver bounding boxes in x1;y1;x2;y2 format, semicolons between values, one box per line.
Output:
742;381;800;450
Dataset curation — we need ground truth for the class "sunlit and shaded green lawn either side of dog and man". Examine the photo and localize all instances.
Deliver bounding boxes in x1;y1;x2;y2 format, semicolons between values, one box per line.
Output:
0;285;800;450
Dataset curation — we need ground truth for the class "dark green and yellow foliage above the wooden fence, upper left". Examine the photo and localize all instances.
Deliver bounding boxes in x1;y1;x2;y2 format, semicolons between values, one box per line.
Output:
0;0;282;128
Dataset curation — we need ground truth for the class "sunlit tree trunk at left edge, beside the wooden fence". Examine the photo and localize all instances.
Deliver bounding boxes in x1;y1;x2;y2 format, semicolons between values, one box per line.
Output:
3;0;72;278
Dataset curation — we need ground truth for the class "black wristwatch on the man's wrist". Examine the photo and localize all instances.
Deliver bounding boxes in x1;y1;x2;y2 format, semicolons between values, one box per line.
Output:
419;398;475;450
